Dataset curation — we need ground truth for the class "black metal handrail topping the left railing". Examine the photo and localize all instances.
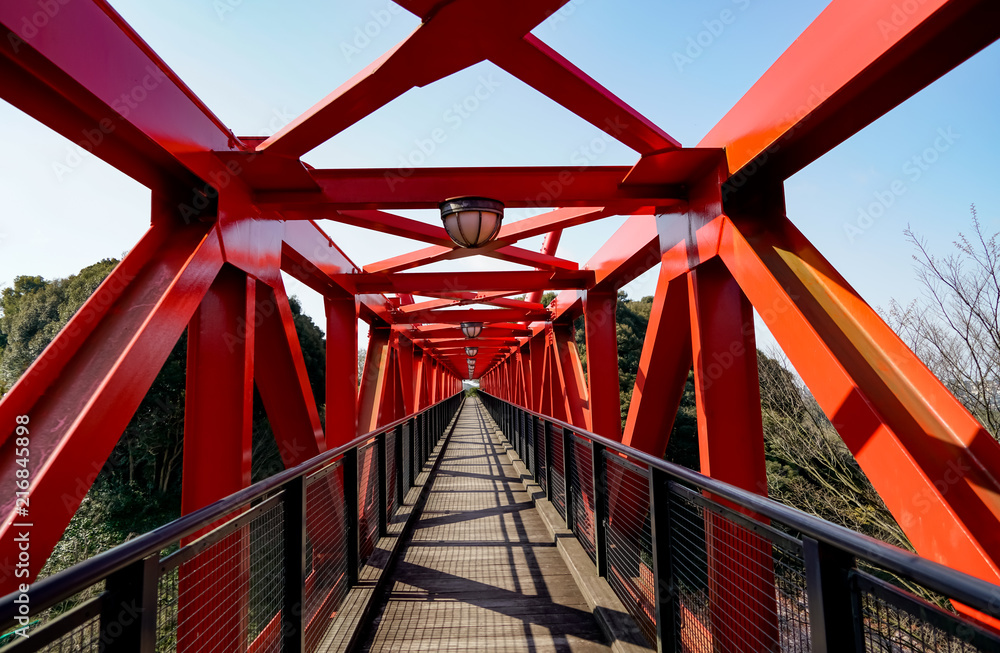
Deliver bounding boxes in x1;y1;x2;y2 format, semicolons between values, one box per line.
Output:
0;392;462;625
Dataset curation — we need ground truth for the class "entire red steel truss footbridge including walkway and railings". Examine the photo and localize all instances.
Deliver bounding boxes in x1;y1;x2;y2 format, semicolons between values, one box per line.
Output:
0;0;1000;652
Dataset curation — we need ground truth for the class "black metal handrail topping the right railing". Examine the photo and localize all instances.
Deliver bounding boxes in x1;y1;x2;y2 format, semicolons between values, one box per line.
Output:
479;390;1000;617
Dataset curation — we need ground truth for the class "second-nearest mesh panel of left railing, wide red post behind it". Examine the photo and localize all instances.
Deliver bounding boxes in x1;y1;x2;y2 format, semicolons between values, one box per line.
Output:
173;502;284;652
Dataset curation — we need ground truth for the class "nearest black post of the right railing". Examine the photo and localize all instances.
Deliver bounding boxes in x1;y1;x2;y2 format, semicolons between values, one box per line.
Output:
802;535;863;653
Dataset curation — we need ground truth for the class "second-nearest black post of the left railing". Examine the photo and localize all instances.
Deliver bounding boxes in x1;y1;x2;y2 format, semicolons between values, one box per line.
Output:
281;475;307;651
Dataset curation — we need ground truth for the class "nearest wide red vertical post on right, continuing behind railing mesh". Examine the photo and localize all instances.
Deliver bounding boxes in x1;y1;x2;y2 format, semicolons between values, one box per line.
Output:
688;258;779;651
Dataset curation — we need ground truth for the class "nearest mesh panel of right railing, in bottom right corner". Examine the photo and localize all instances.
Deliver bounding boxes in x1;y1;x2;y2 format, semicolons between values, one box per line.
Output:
851;573;1000;653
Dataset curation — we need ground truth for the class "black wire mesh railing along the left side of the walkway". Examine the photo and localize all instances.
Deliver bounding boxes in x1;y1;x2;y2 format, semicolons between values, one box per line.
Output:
0;395;462;653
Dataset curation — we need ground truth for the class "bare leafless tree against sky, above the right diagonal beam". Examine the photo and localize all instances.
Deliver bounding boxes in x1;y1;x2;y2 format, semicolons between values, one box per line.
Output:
888;205;1000;439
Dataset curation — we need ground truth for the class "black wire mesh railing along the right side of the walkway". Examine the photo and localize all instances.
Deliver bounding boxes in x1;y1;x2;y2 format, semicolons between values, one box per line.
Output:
479;391;1000;653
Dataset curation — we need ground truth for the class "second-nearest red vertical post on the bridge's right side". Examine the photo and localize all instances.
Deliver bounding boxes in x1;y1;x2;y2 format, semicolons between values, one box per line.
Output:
583;290;622;441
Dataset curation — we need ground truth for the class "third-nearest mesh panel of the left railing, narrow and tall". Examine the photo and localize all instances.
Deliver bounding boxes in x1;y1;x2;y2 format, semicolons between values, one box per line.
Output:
304;460;348;651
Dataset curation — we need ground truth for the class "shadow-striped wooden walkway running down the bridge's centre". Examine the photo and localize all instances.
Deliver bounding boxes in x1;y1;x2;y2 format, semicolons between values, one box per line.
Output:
364;398;610;653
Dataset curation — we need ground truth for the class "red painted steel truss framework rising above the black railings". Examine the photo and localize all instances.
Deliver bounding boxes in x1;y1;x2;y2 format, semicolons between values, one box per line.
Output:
0;0;1000;636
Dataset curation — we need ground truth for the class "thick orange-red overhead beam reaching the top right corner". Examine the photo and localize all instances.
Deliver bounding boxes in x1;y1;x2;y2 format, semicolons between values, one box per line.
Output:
699;0;1000;182
